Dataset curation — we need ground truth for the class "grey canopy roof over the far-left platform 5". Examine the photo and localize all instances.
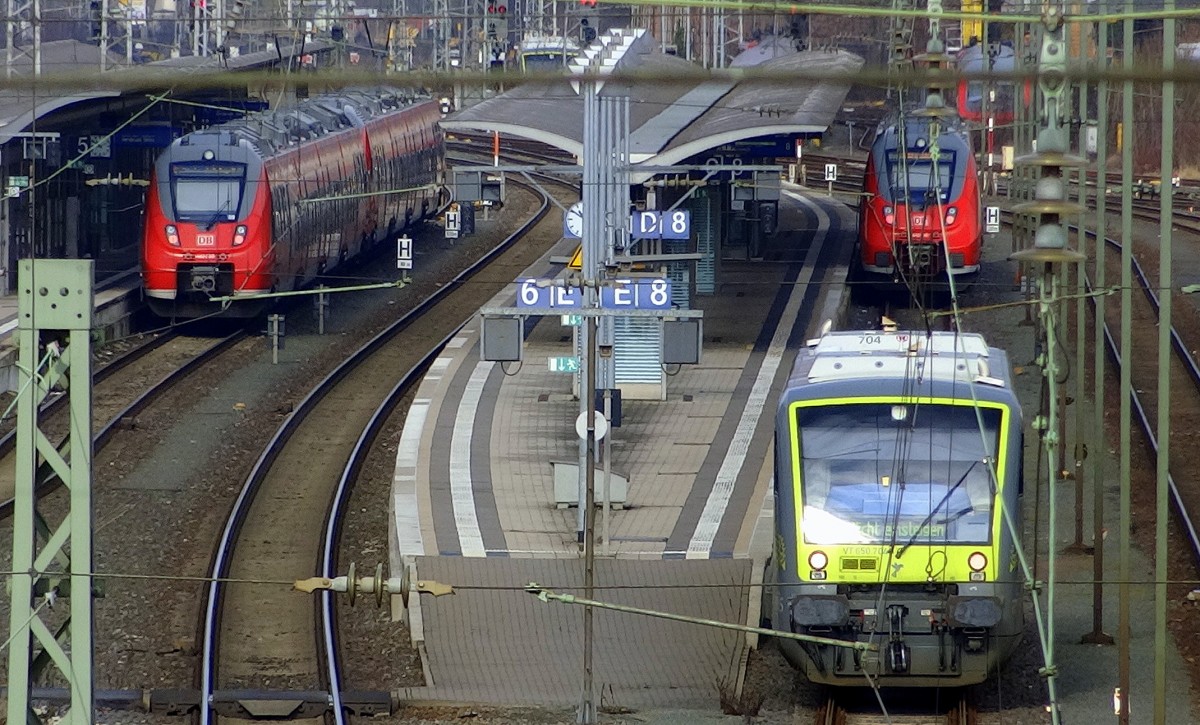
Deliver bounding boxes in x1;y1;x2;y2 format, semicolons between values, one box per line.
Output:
0;40;331;144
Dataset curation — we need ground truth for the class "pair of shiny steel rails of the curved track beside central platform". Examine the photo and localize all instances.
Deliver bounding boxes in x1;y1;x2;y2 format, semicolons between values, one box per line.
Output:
199;168;566;725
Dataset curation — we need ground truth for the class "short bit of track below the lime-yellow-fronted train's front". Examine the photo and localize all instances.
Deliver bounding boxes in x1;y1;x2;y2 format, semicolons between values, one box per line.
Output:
814;690;979;725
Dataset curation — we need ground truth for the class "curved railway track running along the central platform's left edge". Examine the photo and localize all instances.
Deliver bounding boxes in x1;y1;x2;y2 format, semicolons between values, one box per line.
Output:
198;168;576;725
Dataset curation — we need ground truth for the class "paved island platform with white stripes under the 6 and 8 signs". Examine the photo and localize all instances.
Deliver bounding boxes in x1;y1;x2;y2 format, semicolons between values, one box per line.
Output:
390;190;854;708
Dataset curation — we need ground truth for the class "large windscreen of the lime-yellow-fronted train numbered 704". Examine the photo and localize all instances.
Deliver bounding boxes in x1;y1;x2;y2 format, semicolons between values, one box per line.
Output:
796;402;1002;546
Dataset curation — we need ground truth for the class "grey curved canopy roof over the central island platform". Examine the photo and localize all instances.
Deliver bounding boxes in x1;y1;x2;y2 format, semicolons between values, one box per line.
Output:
442;30;863;166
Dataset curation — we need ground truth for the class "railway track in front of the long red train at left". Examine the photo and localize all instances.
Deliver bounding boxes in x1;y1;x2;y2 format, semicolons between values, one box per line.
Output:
0;329;246;516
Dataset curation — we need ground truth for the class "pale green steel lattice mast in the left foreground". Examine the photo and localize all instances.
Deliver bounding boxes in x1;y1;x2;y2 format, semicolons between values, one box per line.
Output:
7;259;95;725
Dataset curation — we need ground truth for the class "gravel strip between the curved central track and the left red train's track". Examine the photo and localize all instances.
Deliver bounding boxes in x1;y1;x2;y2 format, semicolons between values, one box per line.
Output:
0;182;549;721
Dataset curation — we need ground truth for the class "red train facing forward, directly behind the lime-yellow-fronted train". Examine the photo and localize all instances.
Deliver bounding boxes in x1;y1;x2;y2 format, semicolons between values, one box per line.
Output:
858;118;983;289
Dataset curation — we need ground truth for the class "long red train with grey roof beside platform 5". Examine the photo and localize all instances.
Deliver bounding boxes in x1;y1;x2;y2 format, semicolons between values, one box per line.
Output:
142;90;443;318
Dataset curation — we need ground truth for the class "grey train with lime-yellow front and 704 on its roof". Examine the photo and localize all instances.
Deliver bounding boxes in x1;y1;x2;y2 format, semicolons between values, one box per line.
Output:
766;332;1024;687
